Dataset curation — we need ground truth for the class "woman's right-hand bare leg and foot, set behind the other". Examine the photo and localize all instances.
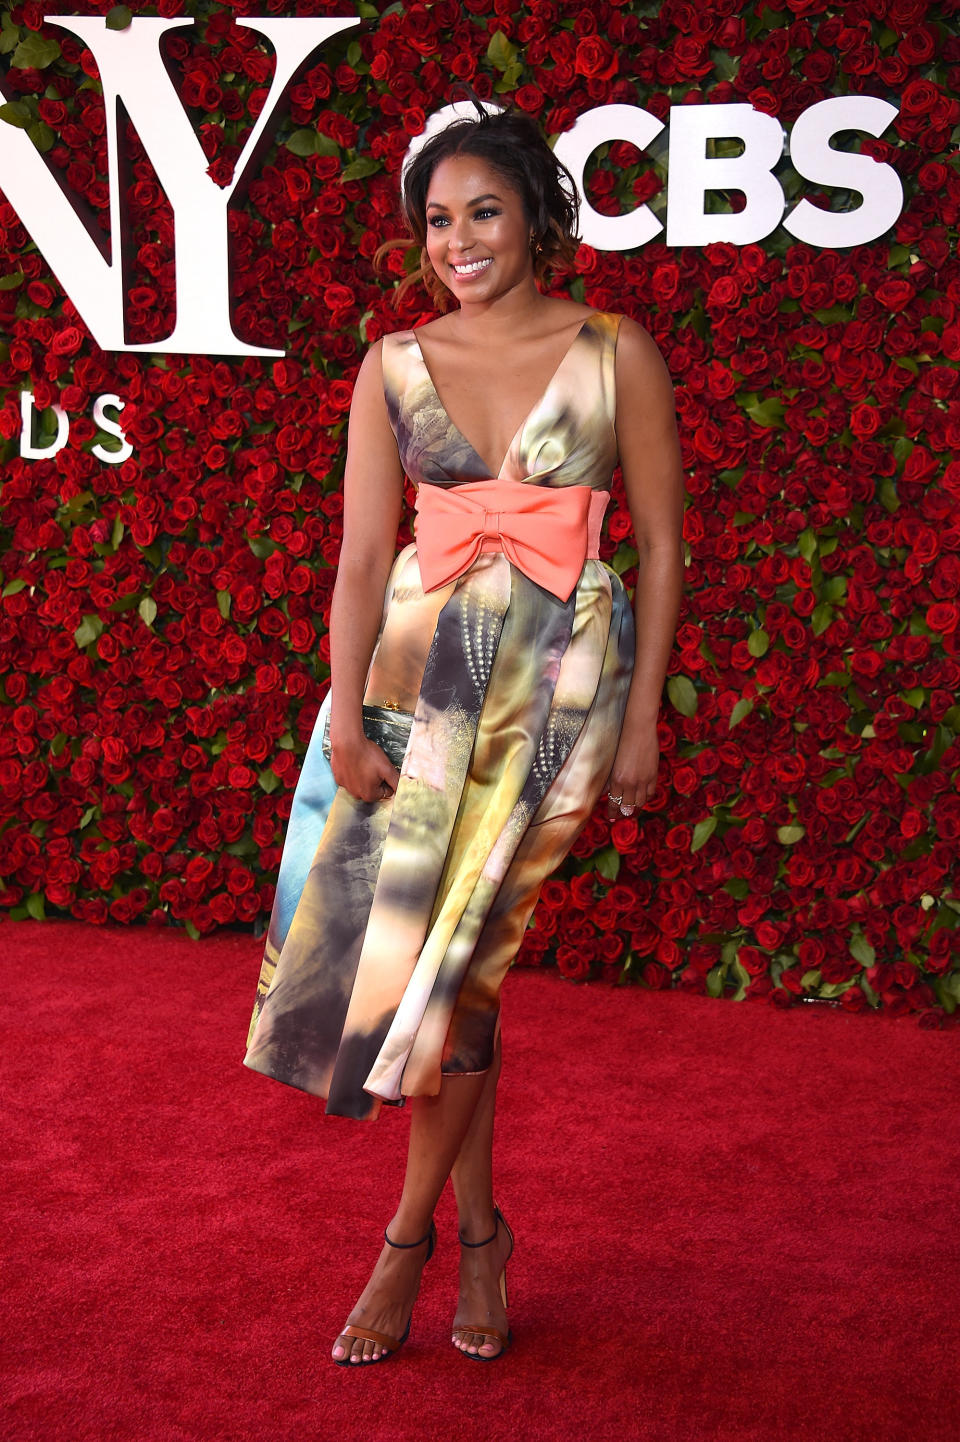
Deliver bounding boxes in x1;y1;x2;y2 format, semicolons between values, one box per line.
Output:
450;1035;510;1357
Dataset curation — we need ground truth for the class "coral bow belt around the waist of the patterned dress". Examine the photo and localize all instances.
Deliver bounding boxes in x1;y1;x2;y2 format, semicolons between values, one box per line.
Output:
415;480;610;601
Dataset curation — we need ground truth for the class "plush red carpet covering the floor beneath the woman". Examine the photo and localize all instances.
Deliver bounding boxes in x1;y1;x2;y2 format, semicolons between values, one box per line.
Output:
7;923;960;1442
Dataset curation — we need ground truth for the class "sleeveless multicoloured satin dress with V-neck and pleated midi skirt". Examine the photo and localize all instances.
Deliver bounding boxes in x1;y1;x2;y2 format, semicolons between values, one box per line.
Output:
244;311;634;1118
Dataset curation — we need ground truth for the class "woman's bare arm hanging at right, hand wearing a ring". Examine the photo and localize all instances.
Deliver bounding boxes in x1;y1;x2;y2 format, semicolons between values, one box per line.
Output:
607;316;685;816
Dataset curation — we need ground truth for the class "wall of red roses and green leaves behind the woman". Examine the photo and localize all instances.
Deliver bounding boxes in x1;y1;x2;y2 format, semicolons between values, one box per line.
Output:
0;0;960;1025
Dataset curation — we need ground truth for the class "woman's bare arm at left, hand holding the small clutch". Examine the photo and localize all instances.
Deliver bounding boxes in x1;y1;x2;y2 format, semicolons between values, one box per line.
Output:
330;340;404;802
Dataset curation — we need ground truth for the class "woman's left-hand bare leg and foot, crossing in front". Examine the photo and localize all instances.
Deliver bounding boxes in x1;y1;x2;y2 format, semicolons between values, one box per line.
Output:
333;1073;489;1366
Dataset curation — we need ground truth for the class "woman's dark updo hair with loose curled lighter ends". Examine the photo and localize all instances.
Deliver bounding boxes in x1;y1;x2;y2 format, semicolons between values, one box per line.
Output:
373;87;579;310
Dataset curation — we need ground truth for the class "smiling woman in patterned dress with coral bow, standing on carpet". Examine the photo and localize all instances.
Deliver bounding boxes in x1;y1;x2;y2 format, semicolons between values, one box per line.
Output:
245;101;683;1364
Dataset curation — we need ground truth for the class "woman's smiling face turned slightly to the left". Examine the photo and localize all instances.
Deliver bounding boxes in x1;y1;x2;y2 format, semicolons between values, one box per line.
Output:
425;156;533;303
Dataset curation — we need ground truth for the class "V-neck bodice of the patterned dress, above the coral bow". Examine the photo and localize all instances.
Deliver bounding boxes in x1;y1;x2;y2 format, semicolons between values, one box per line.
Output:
382;311;620;490
